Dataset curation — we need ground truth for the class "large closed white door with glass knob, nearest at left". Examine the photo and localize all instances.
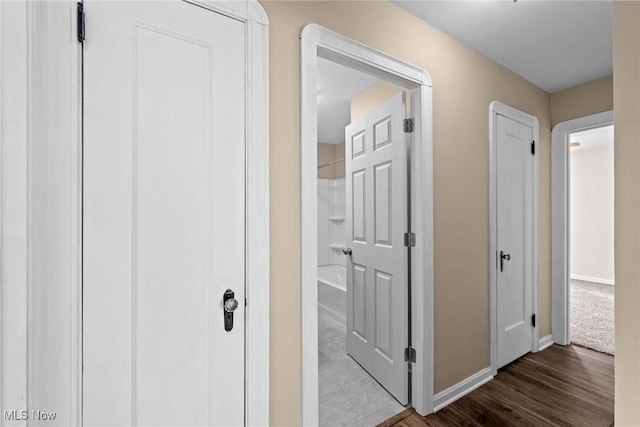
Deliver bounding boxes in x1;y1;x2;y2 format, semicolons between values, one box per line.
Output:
83;1;245;426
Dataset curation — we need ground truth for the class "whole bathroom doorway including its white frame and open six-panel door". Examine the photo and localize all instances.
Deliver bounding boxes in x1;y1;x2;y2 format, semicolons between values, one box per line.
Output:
300;24;433;425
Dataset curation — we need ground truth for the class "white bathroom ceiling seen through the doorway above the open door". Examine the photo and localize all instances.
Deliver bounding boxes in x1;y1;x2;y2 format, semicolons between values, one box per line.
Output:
318;58;380;144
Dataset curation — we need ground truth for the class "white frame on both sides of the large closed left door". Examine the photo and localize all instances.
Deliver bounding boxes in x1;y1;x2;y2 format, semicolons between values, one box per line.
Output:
0;0;269;425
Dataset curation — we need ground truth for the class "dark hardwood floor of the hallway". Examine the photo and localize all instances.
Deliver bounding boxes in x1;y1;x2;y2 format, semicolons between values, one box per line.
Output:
378;345;614;427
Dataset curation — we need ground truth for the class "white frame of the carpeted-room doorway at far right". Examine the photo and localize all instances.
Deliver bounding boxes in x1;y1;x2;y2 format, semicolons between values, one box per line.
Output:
551;110;614;345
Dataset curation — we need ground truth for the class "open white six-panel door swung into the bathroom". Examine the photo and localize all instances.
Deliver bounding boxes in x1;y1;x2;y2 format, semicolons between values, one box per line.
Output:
345;92;408;405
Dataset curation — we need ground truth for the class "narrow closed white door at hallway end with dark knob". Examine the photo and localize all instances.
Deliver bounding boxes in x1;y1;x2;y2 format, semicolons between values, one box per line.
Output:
496;115;534;368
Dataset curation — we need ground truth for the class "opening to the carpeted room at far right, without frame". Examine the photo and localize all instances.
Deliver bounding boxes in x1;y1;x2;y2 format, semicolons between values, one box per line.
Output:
569;124;615;355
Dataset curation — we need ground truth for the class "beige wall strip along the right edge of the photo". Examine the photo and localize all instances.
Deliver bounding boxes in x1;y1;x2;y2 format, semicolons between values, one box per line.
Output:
613;1;640;426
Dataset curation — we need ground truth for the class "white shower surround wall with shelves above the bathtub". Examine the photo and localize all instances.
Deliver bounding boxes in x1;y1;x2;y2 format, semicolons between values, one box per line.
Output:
318;178;347;265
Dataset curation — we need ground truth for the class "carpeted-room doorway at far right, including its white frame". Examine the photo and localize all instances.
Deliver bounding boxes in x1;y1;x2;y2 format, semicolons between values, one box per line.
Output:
551;111;614;352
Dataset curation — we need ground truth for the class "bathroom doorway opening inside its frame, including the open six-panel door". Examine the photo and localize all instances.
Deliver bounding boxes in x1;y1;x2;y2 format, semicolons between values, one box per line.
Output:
317;58;410;426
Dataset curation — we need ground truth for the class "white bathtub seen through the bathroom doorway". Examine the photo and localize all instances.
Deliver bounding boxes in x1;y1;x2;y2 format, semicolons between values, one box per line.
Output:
318;264;347;325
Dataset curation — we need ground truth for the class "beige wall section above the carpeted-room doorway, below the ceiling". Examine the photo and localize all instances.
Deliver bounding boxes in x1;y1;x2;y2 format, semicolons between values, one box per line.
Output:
551;76;613;126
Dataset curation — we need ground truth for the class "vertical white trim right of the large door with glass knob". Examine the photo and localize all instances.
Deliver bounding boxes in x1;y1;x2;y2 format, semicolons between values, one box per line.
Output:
241;0;271;426
